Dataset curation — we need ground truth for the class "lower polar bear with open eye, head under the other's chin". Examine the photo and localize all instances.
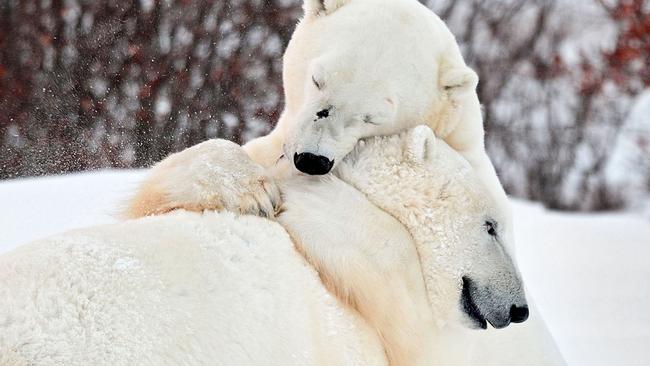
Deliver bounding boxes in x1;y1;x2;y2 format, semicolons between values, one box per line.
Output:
0;127;527;365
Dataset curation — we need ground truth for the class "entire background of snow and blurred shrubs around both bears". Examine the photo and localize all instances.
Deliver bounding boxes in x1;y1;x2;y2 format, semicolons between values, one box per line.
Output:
0;0;650;366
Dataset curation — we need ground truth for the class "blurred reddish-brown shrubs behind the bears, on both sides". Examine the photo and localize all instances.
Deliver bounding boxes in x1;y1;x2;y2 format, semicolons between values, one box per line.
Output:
0;0;650;211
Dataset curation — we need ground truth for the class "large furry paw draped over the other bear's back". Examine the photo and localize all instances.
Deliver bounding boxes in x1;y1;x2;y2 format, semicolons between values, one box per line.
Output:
126;140;281;218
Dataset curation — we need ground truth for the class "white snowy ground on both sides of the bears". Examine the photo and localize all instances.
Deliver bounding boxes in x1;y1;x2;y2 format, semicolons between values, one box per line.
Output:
0;171;650;366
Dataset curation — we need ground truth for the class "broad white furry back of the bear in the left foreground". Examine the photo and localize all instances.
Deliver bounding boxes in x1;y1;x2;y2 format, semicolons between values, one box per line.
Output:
0;211;386;366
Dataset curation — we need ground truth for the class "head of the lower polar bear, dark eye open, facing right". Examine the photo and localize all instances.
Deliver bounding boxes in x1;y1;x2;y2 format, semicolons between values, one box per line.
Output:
336;126;528;329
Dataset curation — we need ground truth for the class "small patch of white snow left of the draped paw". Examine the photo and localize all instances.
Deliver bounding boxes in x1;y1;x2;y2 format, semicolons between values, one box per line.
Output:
0;171;142;252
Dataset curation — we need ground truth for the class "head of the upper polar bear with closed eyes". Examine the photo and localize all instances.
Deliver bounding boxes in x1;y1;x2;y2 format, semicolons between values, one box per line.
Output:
278;0;479;175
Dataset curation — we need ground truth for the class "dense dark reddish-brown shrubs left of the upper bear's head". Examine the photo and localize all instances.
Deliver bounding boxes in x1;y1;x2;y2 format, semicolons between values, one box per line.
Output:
0;0;300;179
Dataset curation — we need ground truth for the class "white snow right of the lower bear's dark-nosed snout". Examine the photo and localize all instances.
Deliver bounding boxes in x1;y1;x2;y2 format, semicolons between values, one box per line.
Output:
515;202;650;366
